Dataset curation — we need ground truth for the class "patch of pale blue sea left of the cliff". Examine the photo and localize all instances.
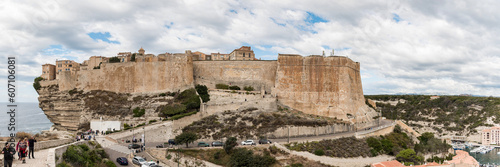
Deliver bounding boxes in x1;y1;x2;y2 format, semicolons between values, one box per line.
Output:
0;103;53;137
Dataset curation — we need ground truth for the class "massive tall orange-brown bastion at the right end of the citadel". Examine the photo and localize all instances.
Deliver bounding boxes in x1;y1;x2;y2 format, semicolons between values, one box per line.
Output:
273;55;375;123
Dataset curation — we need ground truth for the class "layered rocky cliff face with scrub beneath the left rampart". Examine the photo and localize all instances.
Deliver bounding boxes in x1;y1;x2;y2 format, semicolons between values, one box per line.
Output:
37;84;173;131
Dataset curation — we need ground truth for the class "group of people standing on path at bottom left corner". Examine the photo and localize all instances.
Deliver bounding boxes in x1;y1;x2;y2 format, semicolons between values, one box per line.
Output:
2;137;36;167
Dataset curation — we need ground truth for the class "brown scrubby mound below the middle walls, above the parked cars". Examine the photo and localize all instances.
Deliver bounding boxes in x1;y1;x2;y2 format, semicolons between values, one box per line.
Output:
182;108;338;140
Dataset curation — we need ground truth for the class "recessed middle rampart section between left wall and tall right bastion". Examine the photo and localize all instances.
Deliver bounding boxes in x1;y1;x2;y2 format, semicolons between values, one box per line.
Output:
193;61;277;93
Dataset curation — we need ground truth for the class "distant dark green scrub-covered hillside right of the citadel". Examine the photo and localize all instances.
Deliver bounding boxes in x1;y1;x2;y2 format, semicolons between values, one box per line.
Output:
365;95;500;135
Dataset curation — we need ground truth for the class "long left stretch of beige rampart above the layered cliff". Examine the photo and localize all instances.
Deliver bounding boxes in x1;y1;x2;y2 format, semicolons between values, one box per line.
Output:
57;54;193;93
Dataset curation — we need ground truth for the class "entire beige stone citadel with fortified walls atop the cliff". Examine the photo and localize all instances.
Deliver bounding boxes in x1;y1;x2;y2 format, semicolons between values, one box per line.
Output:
38;46;376;130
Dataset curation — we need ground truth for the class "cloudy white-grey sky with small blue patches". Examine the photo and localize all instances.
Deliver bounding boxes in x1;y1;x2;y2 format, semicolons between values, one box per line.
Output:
0;0;500;102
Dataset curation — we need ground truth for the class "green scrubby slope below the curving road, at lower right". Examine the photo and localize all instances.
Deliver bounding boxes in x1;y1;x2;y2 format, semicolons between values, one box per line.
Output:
285;125;451;164
